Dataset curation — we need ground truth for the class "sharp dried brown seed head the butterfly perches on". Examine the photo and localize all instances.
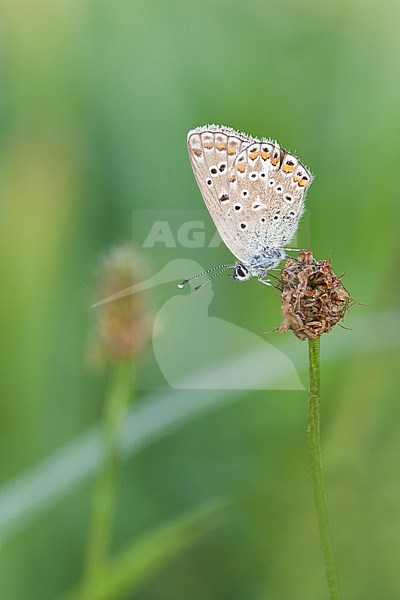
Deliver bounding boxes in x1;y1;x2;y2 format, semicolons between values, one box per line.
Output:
279;250;350;340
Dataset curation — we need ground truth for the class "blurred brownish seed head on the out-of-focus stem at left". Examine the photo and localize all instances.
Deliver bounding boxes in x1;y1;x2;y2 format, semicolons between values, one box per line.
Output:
90;244;151;363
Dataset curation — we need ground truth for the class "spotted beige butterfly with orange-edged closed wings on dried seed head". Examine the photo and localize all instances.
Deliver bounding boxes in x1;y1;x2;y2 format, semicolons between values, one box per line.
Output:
179;125;313;291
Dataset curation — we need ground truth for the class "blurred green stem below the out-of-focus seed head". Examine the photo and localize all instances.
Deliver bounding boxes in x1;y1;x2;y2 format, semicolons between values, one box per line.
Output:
85;360;133;590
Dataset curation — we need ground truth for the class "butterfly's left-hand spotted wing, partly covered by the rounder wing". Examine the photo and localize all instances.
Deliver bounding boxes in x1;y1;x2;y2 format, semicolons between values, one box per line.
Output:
188;125;253;260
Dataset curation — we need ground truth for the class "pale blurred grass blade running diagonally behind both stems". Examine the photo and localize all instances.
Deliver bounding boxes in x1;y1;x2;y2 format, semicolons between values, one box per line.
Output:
0;308;400;547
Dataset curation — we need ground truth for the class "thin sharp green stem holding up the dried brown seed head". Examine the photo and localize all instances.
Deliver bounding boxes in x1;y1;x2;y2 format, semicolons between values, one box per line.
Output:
308;338;341;600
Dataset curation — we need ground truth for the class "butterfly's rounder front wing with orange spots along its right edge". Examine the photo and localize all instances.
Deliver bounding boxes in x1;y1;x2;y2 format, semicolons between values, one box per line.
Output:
228;140;312;263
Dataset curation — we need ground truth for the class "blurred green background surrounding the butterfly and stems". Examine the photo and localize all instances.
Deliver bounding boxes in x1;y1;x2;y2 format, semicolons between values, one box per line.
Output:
0;0;400;600
